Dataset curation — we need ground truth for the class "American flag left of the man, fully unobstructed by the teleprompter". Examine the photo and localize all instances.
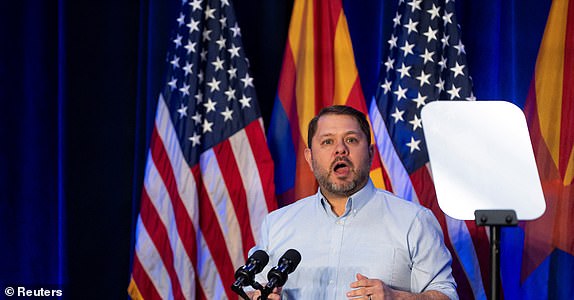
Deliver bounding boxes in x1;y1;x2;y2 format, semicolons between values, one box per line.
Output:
128;0;276;299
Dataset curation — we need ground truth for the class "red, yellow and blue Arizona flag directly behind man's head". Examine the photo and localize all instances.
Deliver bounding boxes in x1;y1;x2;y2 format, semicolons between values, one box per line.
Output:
268;0;385;206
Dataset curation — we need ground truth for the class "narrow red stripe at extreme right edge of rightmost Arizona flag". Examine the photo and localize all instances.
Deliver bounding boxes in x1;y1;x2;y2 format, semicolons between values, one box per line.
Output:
558;1;574;183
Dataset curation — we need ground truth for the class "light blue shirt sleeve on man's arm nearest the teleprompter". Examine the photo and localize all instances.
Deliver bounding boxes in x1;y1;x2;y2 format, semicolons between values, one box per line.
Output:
408;208;458;299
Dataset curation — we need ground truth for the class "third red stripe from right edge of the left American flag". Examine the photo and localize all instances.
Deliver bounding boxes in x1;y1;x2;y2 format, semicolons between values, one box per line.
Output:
191;165;236;299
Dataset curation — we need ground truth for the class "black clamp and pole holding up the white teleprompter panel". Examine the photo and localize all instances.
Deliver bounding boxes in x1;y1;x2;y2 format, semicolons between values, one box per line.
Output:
474;209;518;300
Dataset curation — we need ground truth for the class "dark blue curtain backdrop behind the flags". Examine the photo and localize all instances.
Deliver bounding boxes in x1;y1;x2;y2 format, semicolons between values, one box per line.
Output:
0;0;551;299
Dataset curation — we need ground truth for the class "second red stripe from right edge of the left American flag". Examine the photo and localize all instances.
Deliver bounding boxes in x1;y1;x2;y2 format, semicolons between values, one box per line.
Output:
213;140;255;257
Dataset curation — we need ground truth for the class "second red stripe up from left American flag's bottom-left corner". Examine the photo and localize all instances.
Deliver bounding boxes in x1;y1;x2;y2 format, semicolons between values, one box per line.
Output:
140;188;183;299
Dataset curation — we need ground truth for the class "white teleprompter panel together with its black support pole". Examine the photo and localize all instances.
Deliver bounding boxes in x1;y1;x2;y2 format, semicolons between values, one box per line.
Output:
421;101;546;300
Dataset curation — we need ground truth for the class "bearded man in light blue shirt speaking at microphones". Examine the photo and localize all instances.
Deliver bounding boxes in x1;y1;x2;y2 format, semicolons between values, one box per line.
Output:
252;106;458;300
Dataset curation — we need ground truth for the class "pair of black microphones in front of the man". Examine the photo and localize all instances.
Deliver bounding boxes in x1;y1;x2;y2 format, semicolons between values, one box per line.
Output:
231;249;301;299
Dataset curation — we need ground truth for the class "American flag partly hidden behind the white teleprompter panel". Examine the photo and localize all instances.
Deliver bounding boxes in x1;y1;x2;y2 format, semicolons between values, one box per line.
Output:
369;0;489;299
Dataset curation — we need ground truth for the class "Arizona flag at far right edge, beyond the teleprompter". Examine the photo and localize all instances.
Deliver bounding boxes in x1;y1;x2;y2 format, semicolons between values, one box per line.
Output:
517;0;574;299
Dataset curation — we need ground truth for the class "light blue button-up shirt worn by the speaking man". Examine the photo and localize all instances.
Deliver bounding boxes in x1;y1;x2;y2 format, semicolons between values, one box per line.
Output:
254;180;458;299
